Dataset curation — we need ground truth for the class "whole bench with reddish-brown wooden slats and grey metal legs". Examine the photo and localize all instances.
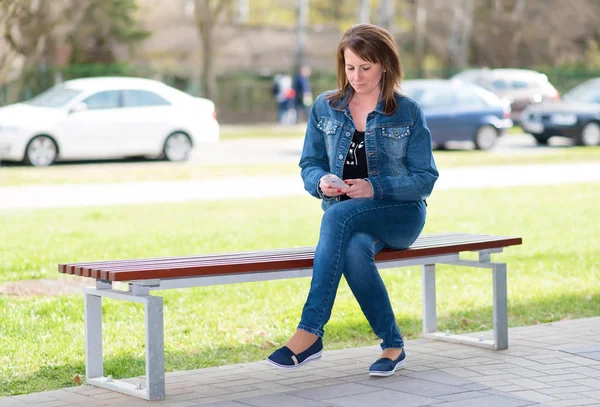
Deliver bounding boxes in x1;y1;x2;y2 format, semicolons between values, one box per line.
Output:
58;233;522;400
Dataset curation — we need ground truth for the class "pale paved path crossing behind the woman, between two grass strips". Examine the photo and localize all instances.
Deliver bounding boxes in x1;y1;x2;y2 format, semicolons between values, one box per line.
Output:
0;162;600;209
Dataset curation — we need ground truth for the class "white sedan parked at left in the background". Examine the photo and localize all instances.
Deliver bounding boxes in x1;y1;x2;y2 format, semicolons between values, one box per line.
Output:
0;77;219;167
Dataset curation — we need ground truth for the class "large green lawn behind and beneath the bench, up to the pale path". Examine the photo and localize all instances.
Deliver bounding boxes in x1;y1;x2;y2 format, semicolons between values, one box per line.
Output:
0;184;600;396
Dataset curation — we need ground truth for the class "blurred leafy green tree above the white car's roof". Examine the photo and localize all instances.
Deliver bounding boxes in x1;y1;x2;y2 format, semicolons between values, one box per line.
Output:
69;0;151;64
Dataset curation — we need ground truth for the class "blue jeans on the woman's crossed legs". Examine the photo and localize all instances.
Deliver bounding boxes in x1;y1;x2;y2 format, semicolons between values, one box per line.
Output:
298;199;426;349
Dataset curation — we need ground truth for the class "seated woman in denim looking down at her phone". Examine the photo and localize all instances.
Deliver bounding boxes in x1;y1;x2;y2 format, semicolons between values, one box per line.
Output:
268;24;438;376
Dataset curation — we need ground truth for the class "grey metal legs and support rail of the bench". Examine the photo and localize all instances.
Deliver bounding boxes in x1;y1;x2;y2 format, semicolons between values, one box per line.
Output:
84;248;508;400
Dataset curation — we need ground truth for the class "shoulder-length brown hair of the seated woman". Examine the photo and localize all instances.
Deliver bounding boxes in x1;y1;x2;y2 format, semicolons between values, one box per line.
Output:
327;24;402;115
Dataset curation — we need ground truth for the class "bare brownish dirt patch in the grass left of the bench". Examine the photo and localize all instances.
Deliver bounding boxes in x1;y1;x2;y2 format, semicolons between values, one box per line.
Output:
0;277;96;297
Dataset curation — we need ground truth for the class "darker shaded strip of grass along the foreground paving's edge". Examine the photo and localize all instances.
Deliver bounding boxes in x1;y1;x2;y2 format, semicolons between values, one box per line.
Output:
0;293;600;397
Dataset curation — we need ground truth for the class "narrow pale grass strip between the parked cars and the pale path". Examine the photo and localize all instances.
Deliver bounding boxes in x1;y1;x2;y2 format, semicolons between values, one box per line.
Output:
0;147;600;186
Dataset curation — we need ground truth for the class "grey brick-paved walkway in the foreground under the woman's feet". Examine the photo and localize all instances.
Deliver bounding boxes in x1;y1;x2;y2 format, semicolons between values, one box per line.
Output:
0;317;600;407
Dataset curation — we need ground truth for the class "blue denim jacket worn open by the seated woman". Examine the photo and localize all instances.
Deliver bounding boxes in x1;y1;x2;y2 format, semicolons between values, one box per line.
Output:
300;92;439;209
